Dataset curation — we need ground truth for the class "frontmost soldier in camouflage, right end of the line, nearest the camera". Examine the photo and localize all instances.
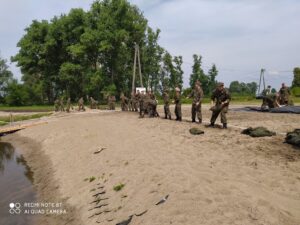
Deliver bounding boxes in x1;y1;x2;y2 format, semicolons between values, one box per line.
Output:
210;82;231;129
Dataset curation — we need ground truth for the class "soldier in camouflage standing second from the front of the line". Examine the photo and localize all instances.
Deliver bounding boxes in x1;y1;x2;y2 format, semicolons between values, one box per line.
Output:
188;81;204;123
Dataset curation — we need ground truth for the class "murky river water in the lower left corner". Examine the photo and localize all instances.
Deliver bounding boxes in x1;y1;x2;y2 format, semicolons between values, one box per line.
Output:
0;141;36;225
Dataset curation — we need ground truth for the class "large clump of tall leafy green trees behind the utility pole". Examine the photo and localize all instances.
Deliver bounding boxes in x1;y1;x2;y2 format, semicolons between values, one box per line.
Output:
12;0;163;103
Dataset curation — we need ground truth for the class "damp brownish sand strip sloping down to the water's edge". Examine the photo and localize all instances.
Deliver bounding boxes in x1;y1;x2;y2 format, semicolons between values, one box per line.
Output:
1;133;81;225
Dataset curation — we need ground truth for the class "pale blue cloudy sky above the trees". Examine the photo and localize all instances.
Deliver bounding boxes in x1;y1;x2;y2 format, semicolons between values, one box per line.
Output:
0;0;300;88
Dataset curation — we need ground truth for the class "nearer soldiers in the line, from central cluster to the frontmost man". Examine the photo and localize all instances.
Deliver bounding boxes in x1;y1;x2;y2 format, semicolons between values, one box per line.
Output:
120;81;231;129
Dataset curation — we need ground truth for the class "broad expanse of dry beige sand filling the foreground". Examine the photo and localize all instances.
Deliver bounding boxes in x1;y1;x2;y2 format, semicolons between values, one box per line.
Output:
4;106;300;225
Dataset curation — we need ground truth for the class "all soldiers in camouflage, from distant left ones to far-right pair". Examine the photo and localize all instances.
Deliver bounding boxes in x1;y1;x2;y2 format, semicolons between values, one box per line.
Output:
55;81;290;129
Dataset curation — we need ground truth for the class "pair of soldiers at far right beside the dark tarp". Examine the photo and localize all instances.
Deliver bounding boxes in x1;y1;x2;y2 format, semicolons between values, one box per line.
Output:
261;83;293;110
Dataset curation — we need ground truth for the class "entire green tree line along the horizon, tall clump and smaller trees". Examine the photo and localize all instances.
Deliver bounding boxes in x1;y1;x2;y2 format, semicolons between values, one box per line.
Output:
0;0;299;105
